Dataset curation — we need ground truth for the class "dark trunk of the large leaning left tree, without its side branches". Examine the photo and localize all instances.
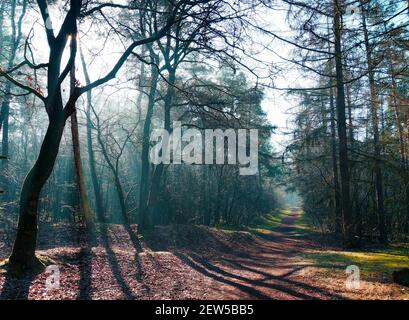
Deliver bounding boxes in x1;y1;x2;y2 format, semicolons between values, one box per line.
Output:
9;0;82;274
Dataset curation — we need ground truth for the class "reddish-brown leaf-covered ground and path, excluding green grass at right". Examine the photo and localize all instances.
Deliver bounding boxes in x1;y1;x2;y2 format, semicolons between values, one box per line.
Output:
0;208;364;299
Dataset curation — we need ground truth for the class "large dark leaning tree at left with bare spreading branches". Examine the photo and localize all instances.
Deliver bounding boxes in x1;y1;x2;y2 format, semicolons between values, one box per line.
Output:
0;0;210;271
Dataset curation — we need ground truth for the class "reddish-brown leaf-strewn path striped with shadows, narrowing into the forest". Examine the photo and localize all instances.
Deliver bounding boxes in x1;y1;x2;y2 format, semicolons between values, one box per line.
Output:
167;208;341;300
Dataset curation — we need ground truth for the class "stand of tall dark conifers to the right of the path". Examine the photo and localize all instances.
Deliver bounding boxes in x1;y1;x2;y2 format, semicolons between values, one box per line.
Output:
289;1;409;242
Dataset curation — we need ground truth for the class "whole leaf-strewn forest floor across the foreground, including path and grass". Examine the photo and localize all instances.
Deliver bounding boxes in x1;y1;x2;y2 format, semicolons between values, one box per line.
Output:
0;208;407;300
